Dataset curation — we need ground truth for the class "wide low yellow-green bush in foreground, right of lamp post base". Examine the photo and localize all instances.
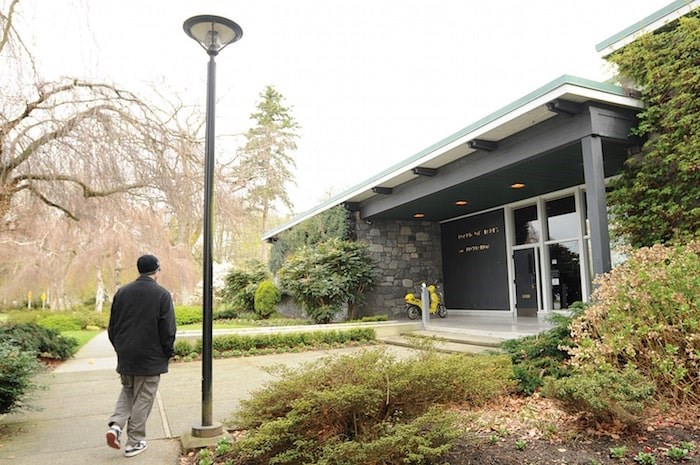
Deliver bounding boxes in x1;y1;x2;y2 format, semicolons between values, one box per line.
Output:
222;351;512;465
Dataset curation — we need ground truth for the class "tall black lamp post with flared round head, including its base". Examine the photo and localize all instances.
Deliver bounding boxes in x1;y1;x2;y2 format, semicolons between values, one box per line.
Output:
182;15;243;438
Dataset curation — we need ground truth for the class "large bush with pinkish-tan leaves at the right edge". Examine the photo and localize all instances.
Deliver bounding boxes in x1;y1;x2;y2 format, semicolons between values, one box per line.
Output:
570;242;700;405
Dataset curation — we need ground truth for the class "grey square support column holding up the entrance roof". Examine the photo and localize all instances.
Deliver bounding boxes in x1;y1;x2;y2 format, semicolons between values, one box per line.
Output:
581;135;612;276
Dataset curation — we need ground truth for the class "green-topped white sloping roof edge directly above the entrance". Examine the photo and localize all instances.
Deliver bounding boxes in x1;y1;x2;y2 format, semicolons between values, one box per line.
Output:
263;74;628;239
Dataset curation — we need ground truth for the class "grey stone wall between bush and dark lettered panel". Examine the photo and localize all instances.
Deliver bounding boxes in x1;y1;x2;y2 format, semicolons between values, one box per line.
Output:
354;213;442;319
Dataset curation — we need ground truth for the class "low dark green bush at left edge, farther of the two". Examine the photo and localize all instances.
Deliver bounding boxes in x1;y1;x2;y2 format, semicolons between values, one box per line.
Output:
0;323;78;360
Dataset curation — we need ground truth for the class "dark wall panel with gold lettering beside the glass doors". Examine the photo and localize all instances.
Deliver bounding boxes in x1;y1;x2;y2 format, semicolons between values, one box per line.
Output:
441;210;510;310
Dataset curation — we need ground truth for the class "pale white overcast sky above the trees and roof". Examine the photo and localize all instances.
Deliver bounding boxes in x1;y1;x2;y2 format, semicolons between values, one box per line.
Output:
16;0;671;212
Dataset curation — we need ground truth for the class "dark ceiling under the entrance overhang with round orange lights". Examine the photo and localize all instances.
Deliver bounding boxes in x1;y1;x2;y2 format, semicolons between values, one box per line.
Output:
368;140;627;221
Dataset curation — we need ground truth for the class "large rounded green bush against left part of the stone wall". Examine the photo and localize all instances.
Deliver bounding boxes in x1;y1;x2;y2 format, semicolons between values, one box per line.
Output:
278;239;375;323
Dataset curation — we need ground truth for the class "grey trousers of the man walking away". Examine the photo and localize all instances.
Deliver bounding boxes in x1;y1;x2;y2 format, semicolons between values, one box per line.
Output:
109;375;160;447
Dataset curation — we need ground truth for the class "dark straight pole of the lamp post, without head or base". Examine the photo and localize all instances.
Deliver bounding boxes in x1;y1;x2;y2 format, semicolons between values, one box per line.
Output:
202;53;216;426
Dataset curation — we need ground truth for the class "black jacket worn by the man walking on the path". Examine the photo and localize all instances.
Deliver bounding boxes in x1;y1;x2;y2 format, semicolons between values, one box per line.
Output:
108;275;176;376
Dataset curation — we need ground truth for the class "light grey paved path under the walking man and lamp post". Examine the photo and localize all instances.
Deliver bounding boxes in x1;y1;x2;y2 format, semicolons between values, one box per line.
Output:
0;333;409;465
